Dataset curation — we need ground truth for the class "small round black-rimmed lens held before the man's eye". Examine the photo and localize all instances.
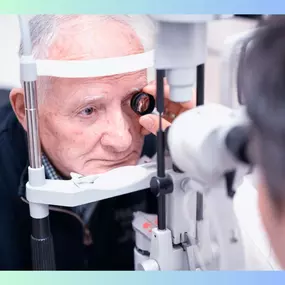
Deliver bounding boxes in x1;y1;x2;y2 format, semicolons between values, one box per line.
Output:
131;92;155;116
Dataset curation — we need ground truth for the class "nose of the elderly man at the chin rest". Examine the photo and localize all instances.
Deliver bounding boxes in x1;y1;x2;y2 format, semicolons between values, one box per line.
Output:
101;111;132;152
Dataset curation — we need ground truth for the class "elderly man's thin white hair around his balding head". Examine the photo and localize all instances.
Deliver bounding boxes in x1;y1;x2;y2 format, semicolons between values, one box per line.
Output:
19;14;155;101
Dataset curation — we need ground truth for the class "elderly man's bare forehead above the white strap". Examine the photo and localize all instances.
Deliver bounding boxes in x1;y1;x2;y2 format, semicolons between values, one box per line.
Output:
48;16;144;60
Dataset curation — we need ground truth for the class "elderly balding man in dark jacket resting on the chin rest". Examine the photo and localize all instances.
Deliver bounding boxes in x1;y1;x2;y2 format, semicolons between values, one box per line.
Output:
0;15;191;270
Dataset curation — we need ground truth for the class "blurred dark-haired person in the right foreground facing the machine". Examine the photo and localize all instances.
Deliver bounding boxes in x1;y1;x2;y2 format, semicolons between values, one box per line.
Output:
238;15;285;269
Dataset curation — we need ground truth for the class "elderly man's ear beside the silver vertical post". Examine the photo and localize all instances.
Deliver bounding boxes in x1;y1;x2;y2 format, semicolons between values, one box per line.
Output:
10;88;27;130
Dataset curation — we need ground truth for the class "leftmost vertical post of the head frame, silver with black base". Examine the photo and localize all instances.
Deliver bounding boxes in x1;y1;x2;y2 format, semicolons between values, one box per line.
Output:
18;16;56;270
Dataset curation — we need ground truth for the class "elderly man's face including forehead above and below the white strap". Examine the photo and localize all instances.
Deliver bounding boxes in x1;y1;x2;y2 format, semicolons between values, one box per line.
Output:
39;18;147;176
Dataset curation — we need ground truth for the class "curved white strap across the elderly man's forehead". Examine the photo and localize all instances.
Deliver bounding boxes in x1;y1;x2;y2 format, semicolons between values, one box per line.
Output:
37;50;154;78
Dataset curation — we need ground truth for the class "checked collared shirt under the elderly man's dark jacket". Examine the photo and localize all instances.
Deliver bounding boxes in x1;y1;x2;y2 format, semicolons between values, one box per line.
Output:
42;154;96;224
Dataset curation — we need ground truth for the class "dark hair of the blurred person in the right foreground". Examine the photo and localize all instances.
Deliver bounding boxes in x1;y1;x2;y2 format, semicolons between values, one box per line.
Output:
238;15;285;206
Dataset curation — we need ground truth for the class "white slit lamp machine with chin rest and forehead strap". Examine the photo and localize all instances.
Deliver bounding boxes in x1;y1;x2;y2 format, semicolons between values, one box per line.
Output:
19;15;258;271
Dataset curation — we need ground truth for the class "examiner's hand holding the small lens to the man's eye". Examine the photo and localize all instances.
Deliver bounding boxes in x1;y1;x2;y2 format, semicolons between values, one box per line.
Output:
139;80;196;135
